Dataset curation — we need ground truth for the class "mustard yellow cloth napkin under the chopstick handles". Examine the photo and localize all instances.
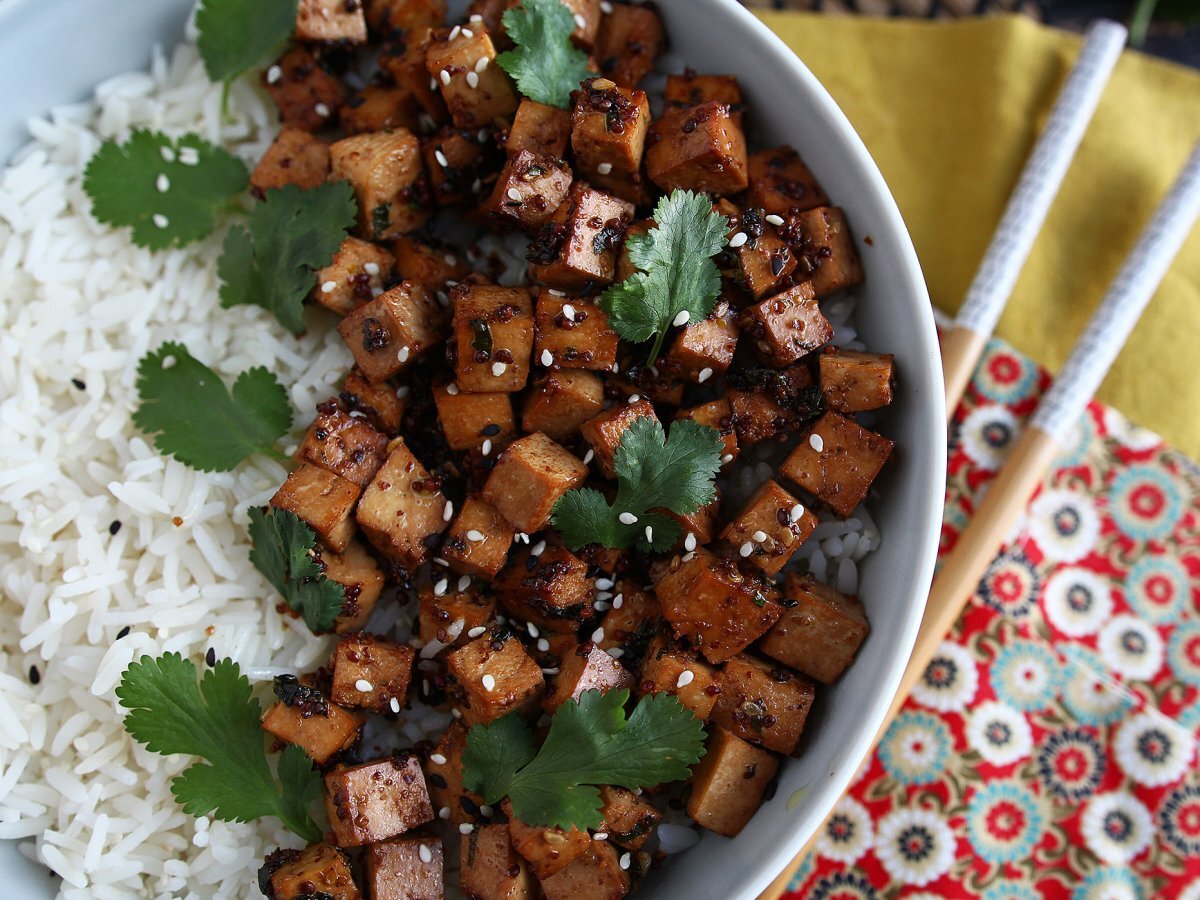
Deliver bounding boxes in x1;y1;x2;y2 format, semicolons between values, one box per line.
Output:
762;12;1200;460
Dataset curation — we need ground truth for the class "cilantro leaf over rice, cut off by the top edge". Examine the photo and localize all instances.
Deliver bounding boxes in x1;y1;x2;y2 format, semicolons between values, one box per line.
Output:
196;0;299;84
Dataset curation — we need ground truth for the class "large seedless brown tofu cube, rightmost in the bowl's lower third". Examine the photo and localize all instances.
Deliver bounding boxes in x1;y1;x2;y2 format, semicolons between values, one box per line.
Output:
758;575;870;684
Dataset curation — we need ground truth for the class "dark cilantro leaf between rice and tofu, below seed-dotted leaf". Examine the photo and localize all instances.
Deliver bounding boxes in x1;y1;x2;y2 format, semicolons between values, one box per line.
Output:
217;181;358;335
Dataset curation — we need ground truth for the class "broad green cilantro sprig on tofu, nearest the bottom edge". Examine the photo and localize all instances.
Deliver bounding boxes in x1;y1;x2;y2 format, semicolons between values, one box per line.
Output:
462;689;704;829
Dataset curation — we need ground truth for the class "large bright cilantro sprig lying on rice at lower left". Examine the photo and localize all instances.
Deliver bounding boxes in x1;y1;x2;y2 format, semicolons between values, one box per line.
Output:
116;653;322;841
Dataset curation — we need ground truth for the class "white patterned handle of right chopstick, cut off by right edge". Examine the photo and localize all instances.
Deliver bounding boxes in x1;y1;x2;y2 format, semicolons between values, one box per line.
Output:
1032;143;1200;443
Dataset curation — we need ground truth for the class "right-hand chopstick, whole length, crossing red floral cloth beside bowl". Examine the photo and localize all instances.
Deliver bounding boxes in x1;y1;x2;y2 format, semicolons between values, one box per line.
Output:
760;143;1200;900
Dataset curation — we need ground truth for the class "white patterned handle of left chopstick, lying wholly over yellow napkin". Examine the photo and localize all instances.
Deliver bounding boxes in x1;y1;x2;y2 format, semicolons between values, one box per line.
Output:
956;19;1128;336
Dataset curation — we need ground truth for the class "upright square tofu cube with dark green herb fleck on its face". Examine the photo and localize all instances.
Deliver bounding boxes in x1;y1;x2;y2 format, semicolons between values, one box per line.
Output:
451;283;534;394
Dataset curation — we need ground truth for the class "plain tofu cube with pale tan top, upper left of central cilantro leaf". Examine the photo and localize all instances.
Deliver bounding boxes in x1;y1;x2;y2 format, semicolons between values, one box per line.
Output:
484;432;588;534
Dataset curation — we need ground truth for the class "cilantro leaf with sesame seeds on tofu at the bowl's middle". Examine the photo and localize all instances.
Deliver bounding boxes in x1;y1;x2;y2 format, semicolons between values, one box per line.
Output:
552;419;724;551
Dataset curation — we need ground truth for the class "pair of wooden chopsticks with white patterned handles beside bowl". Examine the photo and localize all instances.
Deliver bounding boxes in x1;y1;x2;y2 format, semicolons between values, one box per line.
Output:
760;22;1200;900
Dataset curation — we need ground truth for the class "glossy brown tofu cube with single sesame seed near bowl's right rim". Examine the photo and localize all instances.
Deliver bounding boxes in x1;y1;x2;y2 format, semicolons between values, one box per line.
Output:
779;413;894;518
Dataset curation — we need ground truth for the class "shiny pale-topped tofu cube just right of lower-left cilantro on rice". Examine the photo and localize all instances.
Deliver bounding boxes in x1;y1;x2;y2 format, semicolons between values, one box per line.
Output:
325;756;433;847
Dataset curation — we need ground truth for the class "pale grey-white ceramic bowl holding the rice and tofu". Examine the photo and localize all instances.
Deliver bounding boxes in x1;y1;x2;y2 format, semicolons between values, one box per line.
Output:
0;0;946;900
